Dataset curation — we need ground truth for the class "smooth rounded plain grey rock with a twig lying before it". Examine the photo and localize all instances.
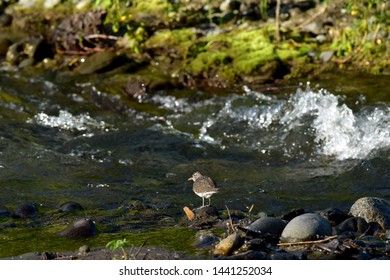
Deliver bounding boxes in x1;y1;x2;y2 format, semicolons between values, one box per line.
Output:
280;213;332;242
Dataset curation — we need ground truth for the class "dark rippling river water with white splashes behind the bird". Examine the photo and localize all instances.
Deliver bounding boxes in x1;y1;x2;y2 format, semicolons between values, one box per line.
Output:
0;69;390;256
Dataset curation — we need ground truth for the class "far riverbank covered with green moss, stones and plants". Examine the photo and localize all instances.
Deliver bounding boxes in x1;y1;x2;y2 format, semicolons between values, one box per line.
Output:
0;0;390;91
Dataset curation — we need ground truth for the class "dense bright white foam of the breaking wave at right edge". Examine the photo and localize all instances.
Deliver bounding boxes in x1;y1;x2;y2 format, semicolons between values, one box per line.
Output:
281;87;390;160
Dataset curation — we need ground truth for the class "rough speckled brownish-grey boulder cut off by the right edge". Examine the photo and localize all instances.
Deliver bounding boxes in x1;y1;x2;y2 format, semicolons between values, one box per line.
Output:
349;197;390;229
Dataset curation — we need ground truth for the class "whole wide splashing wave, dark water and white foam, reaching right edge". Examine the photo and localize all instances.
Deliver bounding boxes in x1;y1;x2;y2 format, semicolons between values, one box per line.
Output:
179;84;390;160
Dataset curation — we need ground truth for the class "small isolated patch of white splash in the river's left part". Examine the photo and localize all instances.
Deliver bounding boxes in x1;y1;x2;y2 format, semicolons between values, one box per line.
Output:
27;110;107;131
